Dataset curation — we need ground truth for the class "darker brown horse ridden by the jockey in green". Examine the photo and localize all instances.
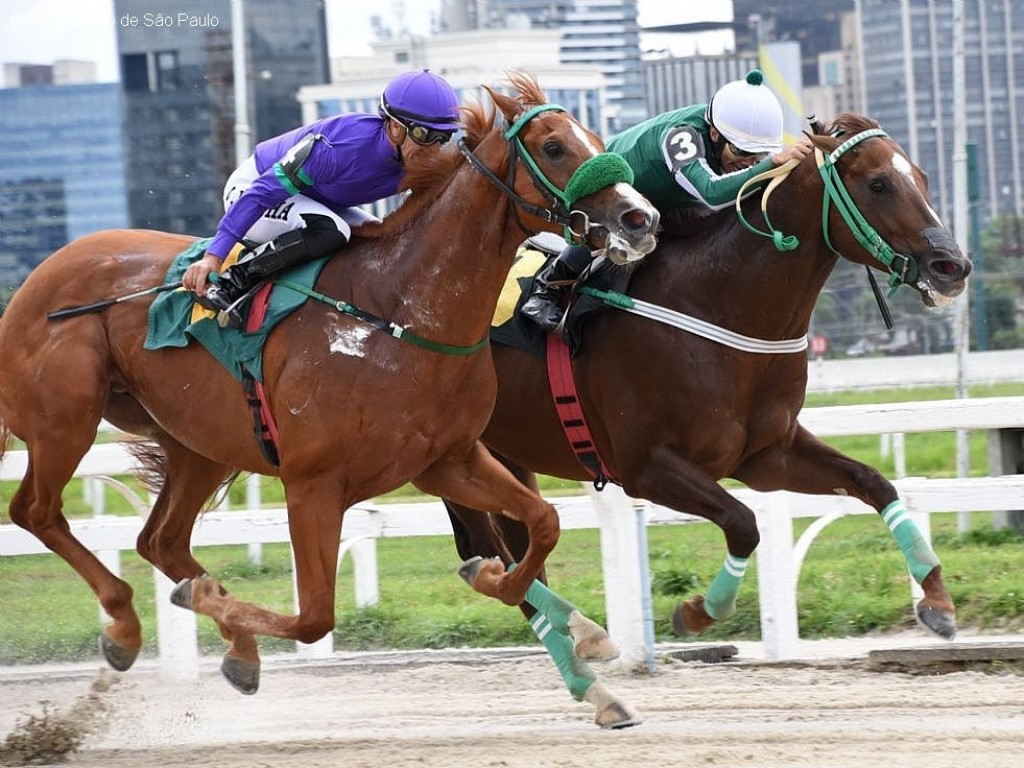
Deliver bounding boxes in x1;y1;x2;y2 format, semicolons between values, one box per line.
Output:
447;115;971;720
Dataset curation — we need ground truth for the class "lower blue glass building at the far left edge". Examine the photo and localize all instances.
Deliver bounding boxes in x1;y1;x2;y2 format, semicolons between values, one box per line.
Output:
0;78;128;291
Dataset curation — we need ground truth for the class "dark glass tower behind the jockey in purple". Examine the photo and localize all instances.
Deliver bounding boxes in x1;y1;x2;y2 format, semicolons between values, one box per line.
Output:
114;0;329;236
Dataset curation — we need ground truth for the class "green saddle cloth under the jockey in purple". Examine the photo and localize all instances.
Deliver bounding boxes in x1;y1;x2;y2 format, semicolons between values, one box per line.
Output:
143;238;329;381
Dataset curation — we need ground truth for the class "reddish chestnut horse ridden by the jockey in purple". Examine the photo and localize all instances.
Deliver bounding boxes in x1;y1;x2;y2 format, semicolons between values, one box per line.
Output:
0;74;658;692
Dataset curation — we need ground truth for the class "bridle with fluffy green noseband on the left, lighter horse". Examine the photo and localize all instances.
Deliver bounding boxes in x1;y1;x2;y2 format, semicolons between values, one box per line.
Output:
459;104;633;240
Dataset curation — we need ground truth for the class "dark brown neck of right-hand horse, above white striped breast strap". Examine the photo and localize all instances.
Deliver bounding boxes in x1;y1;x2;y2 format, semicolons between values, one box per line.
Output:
643;177;837;339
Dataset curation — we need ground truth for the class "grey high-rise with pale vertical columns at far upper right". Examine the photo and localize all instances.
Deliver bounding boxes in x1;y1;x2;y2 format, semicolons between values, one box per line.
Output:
857;0;1024;223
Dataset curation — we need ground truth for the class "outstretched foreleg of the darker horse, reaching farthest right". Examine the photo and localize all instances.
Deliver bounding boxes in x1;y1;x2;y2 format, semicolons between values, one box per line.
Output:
733;427;956;640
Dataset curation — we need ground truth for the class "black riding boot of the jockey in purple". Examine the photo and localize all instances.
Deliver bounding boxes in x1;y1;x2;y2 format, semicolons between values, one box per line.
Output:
199;229;313;328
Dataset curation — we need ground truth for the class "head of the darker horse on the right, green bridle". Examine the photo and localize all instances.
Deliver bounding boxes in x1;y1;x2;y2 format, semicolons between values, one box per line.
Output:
810;114;971;306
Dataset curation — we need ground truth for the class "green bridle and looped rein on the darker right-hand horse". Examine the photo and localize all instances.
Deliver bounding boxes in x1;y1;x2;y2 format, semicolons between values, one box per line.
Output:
736;128;919;296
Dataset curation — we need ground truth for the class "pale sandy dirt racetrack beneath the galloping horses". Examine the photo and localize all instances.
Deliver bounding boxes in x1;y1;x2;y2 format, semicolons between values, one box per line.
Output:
0;636;1024;768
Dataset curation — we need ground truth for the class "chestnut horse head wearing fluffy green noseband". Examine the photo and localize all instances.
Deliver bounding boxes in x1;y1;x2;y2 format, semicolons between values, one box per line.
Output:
460;73;659;264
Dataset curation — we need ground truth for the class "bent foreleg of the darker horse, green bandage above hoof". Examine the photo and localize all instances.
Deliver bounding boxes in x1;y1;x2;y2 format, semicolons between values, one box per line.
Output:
627;446;760;637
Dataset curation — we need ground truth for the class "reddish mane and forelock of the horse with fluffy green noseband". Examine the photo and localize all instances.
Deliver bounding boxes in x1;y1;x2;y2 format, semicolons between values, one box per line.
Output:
358;72;548;238
